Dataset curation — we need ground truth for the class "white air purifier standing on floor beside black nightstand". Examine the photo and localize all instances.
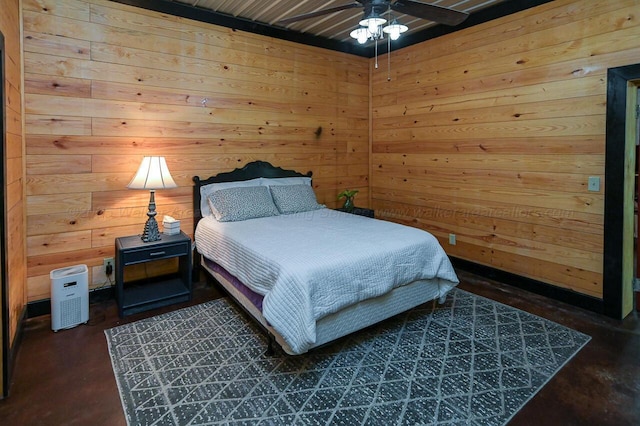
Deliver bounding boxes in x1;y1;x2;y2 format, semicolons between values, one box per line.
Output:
49;265;89;331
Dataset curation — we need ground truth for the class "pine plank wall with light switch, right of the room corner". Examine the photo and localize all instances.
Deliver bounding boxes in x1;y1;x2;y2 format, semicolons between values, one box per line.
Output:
371;0;640;298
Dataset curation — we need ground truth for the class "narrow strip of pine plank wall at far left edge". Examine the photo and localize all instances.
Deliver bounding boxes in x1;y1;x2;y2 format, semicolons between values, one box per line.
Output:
0;0;26;374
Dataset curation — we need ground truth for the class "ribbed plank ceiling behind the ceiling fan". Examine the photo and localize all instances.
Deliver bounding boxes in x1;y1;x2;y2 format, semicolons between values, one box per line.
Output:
168;0;516;55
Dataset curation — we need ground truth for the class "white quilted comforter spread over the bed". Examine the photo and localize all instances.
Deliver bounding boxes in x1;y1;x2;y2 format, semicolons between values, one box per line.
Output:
195;209;458;353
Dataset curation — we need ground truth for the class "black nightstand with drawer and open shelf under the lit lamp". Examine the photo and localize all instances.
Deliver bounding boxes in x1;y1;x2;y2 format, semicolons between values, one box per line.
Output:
115;232;191;317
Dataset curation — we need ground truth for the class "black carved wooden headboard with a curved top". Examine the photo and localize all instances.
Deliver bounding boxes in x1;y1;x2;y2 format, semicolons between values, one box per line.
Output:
193;161;313;236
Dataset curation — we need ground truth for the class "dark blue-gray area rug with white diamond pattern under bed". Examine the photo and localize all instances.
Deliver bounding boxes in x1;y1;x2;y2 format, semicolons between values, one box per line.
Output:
105;289;590;426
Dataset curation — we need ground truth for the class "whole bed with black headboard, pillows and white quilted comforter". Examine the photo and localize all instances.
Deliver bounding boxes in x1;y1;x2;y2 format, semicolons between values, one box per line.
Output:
193;161;458;355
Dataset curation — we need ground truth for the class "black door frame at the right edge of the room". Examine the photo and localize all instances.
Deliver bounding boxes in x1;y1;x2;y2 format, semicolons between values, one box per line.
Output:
603;64;640;318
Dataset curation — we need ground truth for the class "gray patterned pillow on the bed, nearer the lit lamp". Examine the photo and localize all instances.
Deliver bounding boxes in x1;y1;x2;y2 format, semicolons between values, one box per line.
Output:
209;186;279;222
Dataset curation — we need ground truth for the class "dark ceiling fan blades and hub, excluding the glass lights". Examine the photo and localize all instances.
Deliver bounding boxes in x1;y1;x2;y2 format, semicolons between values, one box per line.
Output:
279;0;469;25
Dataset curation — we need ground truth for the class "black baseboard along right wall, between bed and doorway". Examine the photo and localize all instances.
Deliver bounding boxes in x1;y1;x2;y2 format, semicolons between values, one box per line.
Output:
450;257;605;314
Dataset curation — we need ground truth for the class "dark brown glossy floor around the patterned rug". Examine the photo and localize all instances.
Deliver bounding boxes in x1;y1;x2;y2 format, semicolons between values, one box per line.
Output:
0;270;640;426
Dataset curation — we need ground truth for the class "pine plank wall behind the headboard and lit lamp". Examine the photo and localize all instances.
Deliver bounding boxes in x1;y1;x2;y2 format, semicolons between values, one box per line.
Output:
23;0;369;301
